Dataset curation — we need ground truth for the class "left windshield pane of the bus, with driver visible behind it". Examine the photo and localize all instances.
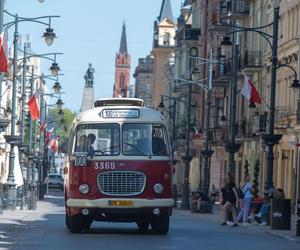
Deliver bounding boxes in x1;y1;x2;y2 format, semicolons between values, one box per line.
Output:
74;123;120;156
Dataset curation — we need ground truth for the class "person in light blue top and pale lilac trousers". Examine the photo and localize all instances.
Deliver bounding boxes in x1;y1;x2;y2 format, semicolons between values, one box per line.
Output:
237;174;253;225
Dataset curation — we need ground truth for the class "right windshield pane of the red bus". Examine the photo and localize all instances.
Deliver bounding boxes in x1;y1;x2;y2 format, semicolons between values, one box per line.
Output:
122;123;169;156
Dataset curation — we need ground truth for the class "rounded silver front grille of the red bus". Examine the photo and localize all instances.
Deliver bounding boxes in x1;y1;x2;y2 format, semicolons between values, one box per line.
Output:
97;171;146;196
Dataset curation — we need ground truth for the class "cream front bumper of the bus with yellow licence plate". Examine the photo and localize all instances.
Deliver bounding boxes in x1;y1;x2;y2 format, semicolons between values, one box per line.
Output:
67;198;175;208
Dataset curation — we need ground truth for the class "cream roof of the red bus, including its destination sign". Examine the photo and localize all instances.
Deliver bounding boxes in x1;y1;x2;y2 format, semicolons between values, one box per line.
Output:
73;98;165;125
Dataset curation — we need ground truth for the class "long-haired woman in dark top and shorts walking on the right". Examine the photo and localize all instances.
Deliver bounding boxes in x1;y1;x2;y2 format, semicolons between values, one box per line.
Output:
220;173;239;227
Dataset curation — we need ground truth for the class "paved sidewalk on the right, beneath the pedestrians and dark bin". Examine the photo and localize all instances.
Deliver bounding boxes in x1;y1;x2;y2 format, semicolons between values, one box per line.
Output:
176;205;300;243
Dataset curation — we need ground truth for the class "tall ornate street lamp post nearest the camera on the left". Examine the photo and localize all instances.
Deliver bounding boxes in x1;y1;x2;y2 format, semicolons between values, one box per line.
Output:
1;10;59;209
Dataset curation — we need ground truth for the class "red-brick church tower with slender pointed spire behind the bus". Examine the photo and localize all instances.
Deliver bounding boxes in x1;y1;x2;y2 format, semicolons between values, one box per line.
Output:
113;23;131;97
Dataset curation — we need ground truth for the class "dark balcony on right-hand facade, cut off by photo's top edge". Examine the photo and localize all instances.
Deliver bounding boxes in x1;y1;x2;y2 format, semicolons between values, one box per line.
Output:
226;0;250;19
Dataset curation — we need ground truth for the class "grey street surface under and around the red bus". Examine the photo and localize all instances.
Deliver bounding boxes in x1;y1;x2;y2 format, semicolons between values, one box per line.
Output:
0;191;300;250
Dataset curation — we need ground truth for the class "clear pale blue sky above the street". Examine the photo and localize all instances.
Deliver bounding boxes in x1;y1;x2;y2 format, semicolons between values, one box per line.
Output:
4;0;182;112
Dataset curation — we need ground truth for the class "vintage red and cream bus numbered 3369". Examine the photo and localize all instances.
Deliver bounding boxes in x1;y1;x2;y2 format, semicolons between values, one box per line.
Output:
64;98;174;234
